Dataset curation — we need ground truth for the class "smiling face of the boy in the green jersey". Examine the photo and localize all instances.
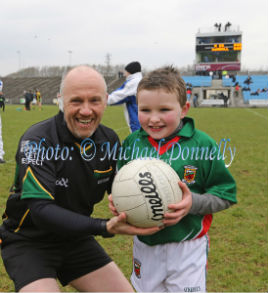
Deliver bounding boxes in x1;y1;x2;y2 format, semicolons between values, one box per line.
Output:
138;89;190;139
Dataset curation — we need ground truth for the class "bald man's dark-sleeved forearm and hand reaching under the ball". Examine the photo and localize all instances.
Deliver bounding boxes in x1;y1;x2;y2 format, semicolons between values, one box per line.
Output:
28;199;160;237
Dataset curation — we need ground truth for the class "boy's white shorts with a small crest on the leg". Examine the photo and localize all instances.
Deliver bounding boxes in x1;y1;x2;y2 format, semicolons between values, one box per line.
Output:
131;235;209;292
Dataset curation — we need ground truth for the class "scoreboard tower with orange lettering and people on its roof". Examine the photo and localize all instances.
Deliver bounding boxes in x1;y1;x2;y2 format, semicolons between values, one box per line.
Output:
195;22;242;76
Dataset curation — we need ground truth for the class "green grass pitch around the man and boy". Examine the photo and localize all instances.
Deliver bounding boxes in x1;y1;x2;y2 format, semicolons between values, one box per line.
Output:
0;106;268;292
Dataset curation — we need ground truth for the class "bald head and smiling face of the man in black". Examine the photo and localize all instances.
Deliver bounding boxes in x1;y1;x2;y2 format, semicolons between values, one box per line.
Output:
63;68;107;139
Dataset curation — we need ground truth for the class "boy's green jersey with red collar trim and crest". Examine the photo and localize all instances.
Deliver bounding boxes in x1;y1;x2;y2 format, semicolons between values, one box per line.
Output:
118;117;236;245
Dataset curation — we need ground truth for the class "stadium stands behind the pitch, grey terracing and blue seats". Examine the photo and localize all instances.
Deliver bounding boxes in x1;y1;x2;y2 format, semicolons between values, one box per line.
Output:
1;75;268;107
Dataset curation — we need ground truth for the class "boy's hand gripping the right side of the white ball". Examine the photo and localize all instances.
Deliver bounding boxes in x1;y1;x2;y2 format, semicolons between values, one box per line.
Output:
163;181;192;226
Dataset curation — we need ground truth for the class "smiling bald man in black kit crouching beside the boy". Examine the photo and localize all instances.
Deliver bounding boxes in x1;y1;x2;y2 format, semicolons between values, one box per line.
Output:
0;66;159;292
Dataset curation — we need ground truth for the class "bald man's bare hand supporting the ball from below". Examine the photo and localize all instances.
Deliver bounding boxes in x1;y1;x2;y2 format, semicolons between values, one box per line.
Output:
107;213;161;235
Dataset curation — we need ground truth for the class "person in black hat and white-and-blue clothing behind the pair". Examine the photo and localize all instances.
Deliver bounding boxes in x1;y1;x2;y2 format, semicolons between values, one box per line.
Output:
108;61;142;132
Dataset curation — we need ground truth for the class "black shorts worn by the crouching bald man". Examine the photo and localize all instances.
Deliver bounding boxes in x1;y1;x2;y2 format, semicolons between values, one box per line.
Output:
1;231;112;291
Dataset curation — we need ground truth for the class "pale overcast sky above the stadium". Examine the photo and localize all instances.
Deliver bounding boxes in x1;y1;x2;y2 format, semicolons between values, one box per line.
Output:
0;0;268;76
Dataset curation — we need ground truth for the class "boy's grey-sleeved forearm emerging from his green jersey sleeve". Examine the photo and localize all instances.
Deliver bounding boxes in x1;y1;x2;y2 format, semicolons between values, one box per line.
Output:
189;192;234;215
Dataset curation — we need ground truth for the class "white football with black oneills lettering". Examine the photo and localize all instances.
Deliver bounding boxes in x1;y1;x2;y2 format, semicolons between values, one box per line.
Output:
112;158;182;228
